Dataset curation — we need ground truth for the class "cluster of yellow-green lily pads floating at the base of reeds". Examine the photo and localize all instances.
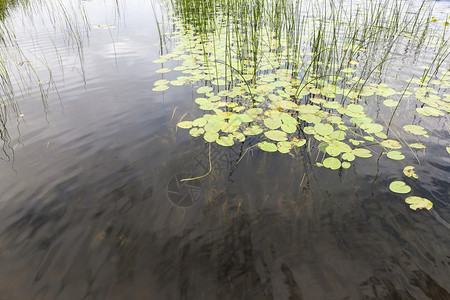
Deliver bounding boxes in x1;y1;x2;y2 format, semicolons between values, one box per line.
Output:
153;0;450;209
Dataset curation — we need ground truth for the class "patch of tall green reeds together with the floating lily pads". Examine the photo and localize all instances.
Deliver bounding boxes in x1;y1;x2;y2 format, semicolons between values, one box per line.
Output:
153;0;450;209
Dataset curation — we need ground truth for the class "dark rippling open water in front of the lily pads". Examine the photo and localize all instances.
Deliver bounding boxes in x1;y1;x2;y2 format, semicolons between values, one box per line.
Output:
0;0;450;299
